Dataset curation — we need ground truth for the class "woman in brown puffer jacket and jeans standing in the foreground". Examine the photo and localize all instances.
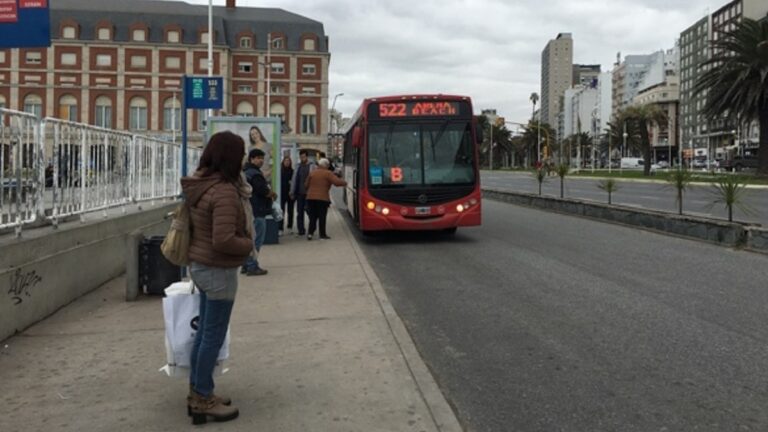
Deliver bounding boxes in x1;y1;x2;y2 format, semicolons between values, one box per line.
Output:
181;132;253;424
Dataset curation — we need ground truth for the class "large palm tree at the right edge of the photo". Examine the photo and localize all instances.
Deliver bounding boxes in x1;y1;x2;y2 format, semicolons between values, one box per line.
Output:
696;18;768;175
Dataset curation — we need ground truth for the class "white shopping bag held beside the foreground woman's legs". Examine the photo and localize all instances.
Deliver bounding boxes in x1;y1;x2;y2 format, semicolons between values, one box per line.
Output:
160;281;229;376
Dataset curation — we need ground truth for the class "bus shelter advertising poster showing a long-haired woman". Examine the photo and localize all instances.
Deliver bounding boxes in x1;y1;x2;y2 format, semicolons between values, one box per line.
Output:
208;117;281;199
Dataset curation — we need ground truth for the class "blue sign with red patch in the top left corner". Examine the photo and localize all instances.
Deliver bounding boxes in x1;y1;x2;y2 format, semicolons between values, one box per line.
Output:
0;0;51;49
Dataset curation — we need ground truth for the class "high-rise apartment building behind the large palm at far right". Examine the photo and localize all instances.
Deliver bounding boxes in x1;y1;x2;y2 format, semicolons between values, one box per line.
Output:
680;0;768;149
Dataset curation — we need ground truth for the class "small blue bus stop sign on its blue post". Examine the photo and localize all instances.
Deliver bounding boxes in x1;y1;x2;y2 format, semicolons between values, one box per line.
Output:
182;75;224;177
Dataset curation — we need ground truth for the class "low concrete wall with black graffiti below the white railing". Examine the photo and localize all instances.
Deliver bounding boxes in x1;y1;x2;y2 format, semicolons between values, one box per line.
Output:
0;201;175;340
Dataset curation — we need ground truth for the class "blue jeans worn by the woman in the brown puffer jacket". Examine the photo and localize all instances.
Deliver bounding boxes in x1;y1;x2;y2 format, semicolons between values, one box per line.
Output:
189;263;237;397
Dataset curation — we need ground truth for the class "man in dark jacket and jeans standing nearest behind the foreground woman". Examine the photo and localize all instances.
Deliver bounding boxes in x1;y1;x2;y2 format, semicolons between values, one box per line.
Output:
241;149;275;276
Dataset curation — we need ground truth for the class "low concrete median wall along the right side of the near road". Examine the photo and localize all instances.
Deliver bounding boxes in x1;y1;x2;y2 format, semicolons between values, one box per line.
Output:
483;188;752;251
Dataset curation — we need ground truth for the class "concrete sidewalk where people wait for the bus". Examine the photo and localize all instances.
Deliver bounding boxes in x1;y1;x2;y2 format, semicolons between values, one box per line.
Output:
0;209;461;432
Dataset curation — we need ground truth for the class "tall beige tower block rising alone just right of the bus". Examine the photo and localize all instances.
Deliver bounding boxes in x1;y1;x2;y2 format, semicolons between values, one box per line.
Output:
541;33;573;132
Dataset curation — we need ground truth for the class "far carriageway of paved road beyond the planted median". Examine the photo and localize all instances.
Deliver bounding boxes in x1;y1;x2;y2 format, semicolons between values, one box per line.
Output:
482;171;768;226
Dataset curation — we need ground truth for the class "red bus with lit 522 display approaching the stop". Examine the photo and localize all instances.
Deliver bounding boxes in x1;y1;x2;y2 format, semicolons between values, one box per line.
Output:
342;95;482;233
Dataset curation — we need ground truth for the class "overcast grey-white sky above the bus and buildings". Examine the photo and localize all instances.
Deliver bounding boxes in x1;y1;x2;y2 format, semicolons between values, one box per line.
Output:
183;0;727;121
